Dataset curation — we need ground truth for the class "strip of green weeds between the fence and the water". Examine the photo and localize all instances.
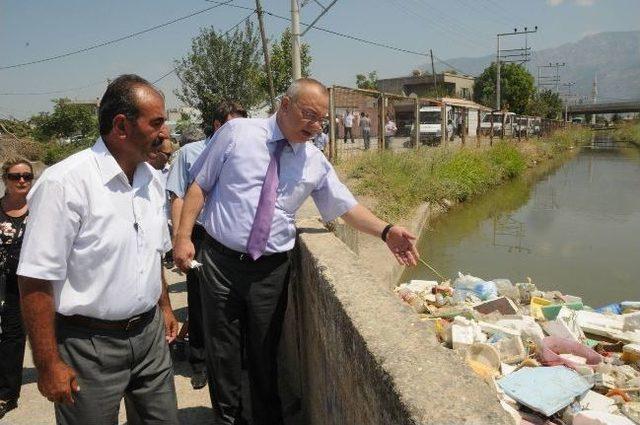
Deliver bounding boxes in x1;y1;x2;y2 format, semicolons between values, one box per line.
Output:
338;129;591;221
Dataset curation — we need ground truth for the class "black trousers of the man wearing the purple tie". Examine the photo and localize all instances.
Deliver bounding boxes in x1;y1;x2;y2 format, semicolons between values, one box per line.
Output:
200;235;291;425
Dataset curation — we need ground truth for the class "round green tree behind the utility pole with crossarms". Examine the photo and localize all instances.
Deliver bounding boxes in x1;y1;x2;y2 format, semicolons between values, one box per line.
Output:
473;63;535;114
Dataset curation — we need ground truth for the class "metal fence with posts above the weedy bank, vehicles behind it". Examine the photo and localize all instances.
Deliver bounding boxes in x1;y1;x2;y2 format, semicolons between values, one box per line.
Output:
325;86;567;163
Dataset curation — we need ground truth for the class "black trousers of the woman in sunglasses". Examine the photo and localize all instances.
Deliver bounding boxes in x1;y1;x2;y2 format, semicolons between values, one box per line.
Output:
0;288;25;401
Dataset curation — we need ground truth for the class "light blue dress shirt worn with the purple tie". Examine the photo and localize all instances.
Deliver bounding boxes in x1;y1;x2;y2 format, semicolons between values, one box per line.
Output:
191;115;357;254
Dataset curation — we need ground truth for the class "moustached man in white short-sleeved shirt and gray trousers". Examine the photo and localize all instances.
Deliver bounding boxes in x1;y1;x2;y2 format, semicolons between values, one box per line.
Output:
18;75;178;425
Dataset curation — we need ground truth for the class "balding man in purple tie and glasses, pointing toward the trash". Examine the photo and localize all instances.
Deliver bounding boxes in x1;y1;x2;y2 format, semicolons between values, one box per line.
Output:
175;79;418;425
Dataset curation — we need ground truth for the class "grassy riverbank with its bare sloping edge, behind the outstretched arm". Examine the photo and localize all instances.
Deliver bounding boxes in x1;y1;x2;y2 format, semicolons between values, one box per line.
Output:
335;128;592;289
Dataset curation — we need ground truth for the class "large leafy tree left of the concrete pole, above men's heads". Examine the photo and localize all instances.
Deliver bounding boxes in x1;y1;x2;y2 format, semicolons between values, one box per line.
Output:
175;21;266;125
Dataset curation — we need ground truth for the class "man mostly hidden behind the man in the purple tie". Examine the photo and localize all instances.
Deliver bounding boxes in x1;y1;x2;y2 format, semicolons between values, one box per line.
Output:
167;101;247;390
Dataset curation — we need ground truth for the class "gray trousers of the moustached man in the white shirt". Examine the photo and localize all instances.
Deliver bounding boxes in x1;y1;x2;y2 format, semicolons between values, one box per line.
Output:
55;309;179;425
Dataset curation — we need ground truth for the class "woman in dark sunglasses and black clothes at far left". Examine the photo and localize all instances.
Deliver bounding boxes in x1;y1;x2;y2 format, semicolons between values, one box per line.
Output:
0;158;33;419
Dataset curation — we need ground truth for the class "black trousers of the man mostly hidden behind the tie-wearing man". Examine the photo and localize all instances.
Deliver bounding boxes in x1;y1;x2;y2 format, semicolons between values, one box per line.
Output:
187;224;207;372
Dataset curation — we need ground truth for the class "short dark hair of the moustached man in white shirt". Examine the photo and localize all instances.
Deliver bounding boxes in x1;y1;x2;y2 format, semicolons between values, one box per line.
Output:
98;74;161;136
